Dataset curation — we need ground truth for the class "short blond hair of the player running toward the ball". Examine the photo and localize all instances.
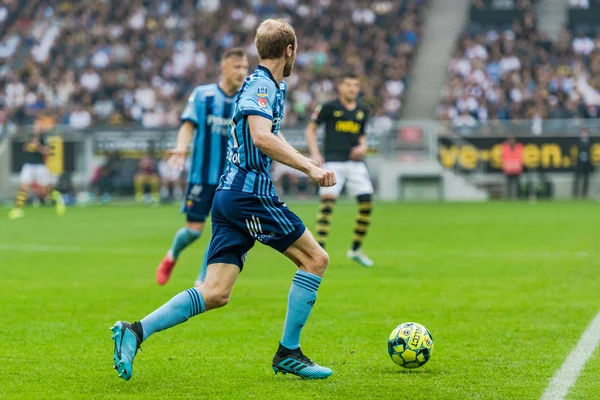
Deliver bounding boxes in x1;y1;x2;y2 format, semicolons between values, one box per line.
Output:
254;18;296;60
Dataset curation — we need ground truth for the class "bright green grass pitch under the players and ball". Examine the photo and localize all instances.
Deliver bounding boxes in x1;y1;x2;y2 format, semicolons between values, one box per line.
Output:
0;202;600;400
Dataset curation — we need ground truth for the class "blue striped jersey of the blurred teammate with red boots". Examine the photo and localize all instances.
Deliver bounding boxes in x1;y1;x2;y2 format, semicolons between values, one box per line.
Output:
181;83;238;185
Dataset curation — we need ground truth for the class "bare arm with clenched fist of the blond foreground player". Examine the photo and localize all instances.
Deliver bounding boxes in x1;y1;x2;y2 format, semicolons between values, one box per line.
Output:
247;115;335;186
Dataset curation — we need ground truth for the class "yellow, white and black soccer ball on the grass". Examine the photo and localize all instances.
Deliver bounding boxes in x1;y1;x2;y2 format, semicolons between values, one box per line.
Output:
388;322;433;368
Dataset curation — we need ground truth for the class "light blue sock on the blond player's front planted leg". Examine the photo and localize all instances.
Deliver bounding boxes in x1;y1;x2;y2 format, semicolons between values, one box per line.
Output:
281;271;321;350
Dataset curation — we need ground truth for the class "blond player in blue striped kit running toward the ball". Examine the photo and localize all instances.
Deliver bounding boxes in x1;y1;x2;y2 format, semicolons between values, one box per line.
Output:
111;19;336;380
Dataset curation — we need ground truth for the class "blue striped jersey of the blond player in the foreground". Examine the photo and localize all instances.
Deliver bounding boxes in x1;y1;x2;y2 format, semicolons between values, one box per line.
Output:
219;65;287;196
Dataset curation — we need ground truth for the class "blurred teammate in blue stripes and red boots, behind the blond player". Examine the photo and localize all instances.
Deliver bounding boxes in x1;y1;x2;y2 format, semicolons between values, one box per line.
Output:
156;48;248;285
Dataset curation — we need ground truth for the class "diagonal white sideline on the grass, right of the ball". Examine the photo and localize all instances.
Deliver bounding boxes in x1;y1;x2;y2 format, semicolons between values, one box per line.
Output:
541;312;600;400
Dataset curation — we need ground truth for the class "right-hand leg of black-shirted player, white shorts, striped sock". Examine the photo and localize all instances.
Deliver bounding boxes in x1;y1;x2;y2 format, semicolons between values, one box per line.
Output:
348;161;374;267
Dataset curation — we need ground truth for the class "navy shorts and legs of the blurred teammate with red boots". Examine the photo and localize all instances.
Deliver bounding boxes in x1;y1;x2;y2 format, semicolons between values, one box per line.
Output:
156;183;216;285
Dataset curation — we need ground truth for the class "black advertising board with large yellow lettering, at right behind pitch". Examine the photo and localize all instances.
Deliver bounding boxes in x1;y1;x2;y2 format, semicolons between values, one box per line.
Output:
438;136;600;173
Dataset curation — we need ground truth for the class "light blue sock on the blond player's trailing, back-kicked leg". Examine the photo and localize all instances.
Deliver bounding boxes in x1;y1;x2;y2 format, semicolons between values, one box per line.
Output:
140;288;206;340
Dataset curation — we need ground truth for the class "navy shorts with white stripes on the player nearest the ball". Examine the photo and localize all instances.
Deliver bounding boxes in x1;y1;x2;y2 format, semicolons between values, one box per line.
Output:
208;190;306;269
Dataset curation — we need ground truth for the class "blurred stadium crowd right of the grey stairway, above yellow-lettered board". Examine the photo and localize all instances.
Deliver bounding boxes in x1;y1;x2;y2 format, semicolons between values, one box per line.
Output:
437;0;600;134
